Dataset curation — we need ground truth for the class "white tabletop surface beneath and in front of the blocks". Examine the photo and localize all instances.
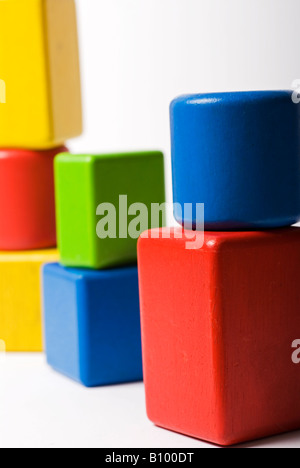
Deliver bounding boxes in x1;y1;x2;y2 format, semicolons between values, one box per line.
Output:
0;354;300;449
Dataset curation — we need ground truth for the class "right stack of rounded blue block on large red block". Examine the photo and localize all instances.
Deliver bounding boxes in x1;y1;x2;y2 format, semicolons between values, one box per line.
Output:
138;91;300;445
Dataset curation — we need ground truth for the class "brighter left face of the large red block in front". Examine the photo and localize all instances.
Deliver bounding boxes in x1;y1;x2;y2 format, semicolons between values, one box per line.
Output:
138;238;222;442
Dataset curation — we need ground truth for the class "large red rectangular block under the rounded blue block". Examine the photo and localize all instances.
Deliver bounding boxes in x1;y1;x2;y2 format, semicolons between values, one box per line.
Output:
138;228;300;446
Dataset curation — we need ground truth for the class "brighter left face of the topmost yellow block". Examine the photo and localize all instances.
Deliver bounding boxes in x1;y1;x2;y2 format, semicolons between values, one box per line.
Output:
0;0;53;148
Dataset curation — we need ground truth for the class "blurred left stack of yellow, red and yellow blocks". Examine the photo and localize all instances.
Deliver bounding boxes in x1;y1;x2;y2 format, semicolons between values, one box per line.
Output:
0;0;82;351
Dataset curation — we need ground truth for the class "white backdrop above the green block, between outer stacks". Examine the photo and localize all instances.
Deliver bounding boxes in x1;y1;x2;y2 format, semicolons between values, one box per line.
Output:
69;0;300;207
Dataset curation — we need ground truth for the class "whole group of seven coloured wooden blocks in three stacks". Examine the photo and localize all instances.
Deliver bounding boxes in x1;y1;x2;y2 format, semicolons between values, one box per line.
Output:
0;0;300;445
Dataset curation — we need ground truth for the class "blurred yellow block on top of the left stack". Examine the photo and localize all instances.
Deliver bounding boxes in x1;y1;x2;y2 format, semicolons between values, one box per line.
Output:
0;0;82;149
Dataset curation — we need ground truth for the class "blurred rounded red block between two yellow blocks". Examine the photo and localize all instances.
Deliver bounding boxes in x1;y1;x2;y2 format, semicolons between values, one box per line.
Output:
0;147;66;250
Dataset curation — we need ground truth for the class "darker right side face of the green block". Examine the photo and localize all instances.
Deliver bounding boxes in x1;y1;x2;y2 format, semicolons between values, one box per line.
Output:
94;152;165;266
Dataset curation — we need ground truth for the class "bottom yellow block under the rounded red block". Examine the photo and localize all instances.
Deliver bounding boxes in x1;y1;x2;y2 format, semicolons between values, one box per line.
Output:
0;250;58;352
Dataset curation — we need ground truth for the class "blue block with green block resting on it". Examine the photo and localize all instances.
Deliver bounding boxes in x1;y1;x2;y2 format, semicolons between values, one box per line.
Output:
43;264;143;387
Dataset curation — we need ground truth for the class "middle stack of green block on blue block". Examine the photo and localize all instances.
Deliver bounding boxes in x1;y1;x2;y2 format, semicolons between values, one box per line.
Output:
43;152;165;387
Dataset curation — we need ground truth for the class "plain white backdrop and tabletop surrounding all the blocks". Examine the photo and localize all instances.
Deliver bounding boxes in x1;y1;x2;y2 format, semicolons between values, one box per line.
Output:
0;0;300;448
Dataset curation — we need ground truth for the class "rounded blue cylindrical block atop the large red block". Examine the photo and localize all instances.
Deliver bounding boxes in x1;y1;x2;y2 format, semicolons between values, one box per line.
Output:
171;91;300;231
